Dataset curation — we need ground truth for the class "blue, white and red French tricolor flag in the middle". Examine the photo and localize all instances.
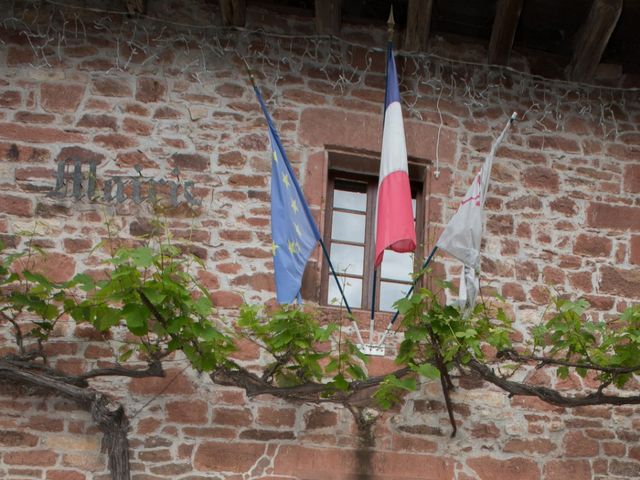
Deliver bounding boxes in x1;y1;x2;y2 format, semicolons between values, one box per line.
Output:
375;44;416;267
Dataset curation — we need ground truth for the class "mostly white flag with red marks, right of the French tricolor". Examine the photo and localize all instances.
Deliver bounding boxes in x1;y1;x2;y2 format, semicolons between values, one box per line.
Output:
436;113;516;308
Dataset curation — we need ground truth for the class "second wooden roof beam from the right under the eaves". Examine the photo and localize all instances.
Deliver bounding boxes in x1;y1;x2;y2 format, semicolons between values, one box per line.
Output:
488;0;524;65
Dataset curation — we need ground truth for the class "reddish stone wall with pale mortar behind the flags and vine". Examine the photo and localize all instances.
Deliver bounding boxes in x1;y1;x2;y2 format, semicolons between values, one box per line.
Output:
0;2;640;480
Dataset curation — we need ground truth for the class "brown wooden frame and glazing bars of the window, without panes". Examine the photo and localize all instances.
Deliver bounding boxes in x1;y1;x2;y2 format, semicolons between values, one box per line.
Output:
320;152;426;312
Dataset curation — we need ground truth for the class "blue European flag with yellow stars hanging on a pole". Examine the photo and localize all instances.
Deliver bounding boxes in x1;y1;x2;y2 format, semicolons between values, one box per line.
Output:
254;87;320;303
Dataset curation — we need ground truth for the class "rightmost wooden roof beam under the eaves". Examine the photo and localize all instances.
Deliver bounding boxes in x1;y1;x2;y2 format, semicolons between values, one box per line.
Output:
567;0;623;81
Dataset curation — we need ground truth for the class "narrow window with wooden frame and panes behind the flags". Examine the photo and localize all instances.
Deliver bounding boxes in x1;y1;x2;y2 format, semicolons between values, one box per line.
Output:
320;153;425;311
